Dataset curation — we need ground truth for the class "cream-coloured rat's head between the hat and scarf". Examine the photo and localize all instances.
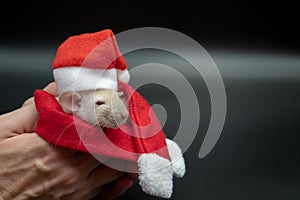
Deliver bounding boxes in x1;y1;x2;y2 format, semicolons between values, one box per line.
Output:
59;89;128;128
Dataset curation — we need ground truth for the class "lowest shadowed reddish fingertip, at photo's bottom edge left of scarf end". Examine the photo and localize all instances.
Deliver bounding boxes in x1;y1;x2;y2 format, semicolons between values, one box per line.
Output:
99;176;134;200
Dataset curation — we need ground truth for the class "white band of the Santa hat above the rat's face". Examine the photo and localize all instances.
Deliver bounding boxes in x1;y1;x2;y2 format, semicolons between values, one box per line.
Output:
53;66;118;94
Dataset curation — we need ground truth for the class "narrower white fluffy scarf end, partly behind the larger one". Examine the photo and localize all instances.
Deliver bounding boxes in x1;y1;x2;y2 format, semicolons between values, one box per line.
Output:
166;138;186;178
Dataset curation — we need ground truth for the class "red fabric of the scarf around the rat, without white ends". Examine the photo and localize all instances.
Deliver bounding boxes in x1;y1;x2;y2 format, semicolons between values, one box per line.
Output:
34;82;170;161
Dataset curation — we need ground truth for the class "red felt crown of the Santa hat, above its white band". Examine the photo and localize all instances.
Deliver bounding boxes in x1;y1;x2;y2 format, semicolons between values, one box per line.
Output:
52;29;127;70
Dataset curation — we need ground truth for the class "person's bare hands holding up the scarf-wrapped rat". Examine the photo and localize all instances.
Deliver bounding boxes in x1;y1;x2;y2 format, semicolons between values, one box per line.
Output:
0;83;136;200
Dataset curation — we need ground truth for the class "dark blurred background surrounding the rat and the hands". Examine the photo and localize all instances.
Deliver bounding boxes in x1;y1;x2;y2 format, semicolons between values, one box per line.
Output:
0;1;300;200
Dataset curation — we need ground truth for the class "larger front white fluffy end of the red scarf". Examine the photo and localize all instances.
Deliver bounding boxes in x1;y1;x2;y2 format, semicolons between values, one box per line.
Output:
138;153;173;198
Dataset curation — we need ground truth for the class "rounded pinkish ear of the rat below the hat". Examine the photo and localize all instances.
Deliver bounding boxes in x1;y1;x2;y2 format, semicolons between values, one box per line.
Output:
58;92;82;113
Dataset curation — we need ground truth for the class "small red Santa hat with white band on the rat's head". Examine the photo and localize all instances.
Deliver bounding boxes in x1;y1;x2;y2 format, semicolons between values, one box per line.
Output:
52;29;130;94
